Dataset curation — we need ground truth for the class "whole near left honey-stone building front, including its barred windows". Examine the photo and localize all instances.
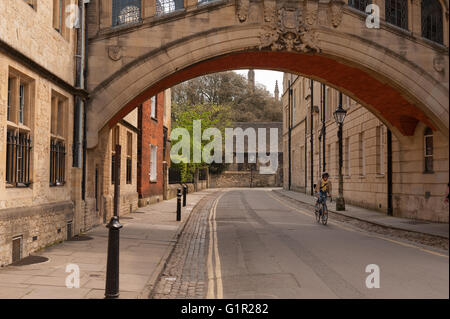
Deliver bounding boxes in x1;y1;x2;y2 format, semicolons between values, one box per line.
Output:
0;0;84;266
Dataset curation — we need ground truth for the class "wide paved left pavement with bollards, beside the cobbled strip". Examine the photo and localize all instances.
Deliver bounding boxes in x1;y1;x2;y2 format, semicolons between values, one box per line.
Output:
0;190;216;299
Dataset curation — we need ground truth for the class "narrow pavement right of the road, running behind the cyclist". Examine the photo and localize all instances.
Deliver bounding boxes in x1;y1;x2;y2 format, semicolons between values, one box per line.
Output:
273;188;449;238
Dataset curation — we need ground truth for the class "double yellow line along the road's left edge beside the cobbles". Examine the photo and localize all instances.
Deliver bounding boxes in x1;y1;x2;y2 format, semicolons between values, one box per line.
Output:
207;194;223;299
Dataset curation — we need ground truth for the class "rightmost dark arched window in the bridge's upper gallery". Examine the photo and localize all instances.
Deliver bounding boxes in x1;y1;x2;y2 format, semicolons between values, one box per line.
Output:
421;0;444;44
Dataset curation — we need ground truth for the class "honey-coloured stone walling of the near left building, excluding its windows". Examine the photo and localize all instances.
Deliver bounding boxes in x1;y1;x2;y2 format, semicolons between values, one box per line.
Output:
0;0;80;265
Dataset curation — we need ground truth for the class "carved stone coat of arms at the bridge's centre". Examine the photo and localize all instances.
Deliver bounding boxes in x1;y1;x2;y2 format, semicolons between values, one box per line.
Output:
259;8;320;53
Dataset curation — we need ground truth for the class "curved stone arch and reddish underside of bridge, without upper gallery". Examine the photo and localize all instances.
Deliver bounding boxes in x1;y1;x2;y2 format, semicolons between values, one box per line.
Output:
88;0;449;148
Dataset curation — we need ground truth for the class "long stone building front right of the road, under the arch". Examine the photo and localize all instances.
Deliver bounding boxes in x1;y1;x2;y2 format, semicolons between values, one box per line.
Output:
282;73;449;222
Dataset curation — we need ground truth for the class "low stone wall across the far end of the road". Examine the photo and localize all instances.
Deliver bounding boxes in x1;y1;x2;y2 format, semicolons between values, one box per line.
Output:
210;171;282;188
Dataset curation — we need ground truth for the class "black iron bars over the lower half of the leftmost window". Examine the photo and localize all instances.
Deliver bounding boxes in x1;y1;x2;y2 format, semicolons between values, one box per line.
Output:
6;130;31;187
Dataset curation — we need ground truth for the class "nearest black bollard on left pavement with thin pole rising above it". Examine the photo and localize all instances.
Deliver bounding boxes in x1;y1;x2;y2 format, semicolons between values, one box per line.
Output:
105;145;122;299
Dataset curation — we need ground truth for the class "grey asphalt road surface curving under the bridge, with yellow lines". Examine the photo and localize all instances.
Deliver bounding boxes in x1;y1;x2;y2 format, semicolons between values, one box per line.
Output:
207;189;449;299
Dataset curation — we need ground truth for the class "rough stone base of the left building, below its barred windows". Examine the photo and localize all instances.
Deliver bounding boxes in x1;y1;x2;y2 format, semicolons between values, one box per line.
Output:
0;201;77;266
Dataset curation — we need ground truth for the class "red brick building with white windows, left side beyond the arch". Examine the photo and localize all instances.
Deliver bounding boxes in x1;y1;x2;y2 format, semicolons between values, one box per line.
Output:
137;90;171;206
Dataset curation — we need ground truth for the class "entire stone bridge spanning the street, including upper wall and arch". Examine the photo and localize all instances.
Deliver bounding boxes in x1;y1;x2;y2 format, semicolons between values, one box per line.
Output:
87;0;449;148
